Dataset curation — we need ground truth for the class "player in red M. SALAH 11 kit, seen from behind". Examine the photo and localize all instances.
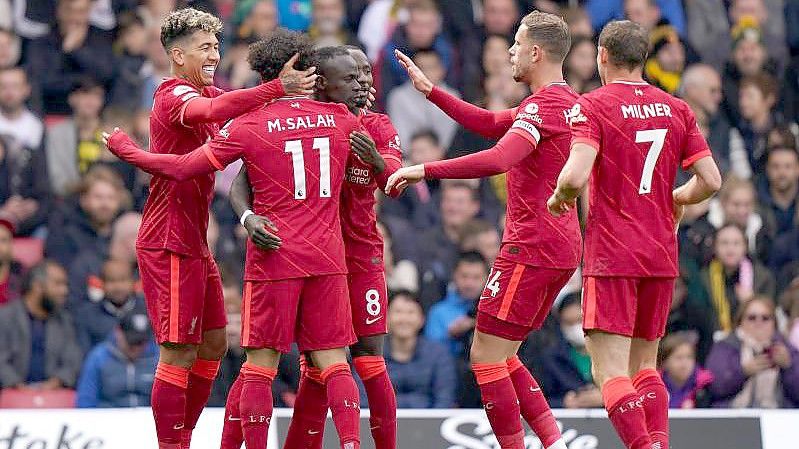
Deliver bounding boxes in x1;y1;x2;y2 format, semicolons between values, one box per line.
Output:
108;29;367;449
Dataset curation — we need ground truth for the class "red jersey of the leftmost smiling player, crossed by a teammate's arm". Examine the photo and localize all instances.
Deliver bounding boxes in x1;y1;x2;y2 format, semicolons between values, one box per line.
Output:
136;78;224;257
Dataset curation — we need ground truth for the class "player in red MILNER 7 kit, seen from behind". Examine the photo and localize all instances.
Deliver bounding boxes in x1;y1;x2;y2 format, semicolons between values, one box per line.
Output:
548;21;721;449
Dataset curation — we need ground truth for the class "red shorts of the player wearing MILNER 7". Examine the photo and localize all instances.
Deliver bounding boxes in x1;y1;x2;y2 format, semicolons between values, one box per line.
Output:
583;276;674;341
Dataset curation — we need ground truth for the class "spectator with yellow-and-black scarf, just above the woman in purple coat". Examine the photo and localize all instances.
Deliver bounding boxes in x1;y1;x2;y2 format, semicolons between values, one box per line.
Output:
702;224;777;333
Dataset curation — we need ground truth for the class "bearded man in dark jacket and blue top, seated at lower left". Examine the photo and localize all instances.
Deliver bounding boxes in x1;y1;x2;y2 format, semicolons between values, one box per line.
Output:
0;260;82;390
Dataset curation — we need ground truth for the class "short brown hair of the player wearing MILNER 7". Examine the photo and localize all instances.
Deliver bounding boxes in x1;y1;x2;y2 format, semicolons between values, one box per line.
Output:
599;20;649;70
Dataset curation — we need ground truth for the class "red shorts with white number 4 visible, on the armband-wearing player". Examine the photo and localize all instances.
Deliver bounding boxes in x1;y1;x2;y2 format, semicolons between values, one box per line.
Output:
477;257;574;341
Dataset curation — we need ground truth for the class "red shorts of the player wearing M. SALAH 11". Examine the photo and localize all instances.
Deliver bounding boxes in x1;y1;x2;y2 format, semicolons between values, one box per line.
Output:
241;274;357;352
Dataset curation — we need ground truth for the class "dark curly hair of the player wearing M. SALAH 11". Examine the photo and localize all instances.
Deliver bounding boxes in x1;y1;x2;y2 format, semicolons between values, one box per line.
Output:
247;28;313;81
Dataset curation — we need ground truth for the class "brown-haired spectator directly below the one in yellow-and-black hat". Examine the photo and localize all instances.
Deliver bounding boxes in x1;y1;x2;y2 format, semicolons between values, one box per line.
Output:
730;74;777;173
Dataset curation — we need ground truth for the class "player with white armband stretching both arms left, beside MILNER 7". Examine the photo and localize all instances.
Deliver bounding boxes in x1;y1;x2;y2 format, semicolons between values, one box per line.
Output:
387;11;581;449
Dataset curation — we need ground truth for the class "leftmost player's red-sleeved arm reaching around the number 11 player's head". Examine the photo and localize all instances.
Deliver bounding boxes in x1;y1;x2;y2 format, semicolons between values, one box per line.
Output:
181;54;317;126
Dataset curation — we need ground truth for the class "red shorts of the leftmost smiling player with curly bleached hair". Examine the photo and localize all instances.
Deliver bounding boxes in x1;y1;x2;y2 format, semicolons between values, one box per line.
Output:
136;248;227;345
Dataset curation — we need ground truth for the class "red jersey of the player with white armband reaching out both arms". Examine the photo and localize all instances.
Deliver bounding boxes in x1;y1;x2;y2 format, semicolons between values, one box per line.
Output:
500;83;581;269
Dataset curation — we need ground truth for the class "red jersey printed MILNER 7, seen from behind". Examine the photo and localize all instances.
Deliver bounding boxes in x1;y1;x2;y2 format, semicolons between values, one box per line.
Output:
569;81;710;277
